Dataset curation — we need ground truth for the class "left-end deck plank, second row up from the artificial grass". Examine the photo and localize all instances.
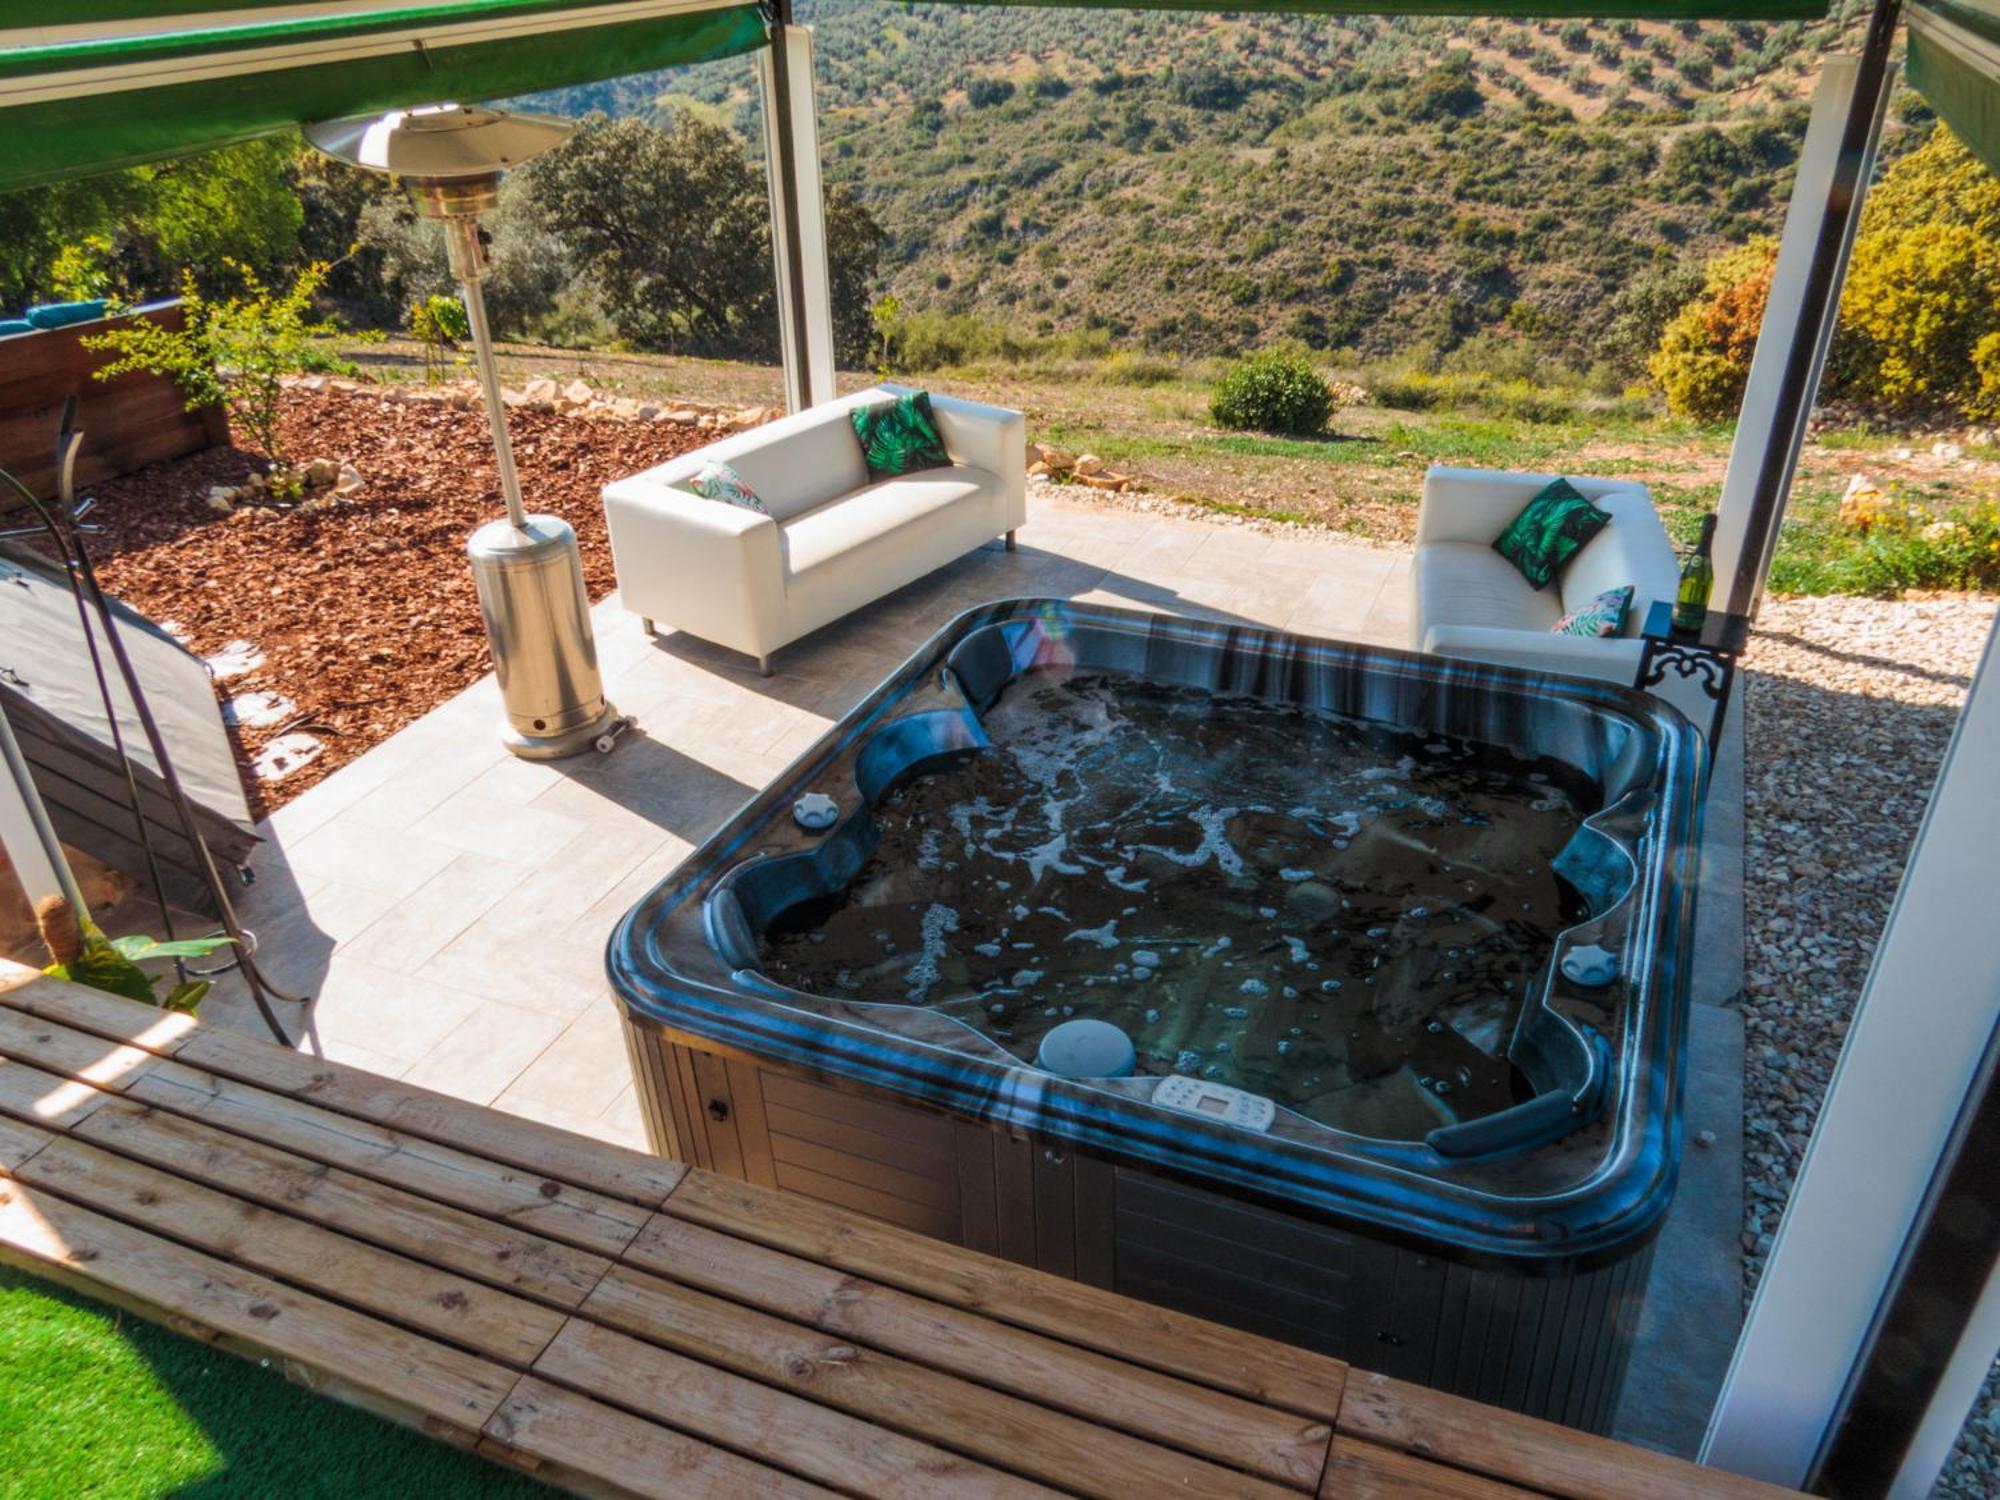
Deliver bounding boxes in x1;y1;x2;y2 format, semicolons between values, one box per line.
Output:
12;1140;566;1368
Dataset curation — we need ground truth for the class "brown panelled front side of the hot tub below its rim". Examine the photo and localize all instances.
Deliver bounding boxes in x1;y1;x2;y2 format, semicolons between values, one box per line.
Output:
626;1022;1652;1432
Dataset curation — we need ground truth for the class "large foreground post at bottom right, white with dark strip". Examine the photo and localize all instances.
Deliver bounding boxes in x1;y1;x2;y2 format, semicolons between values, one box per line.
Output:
1702;608;2000;1500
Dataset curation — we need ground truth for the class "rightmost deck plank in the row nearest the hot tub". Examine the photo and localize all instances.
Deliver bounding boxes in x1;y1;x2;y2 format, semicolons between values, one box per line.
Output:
1338;1370;1794;1500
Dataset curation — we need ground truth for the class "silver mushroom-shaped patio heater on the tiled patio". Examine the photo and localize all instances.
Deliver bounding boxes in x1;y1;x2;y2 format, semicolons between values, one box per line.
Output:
306;104;632;760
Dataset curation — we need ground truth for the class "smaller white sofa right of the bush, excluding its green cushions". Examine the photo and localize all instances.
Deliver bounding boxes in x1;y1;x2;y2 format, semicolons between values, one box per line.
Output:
1410;468;1680;684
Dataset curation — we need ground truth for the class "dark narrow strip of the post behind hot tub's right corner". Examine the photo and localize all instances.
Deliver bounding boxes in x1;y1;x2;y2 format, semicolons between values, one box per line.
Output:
1728;0;1902;616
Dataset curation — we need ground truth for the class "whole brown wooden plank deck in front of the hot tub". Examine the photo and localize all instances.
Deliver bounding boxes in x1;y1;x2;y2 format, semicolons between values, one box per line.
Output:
0;964;1784;1500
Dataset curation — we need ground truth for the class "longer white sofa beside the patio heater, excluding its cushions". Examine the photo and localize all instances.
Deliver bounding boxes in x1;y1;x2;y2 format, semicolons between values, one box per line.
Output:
604;386;1028;676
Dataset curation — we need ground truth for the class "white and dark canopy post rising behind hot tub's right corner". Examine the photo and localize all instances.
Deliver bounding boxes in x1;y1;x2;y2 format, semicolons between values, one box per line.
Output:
1714;0;1902;616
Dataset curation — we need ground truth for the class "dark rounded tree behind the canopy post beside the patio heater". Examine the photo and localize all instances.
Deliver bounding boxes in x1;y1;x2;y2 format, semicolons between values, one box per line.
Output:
522;114;882;362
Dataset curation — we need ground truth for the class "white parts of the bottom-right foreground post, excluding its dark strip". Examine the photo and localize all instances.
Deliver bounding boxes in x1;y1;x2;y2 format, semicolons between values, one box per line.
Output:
1702;612;2000;1494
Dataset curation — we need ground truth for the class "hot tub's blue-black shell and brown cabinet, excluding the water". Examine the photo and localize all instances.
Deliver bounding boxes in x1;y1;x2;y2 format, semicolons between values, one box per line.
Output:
608;600;1702;1432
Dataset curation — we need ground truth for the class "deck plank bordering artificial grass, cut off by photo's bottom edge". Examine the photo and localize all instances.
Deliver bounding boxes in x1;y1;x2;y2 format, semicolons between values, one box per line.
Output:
480;1376;834;1500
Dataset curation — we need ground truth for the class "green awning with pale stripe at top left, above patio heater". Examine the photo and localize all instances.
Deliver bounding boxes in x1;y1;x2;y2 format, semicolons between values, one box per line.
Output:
0;0;764;190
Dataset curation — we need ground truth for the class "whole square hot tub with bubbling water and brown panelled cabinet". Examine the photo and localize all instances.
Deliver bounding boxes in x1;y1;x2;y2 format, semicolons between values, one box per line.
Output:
610;600;1702;1430
